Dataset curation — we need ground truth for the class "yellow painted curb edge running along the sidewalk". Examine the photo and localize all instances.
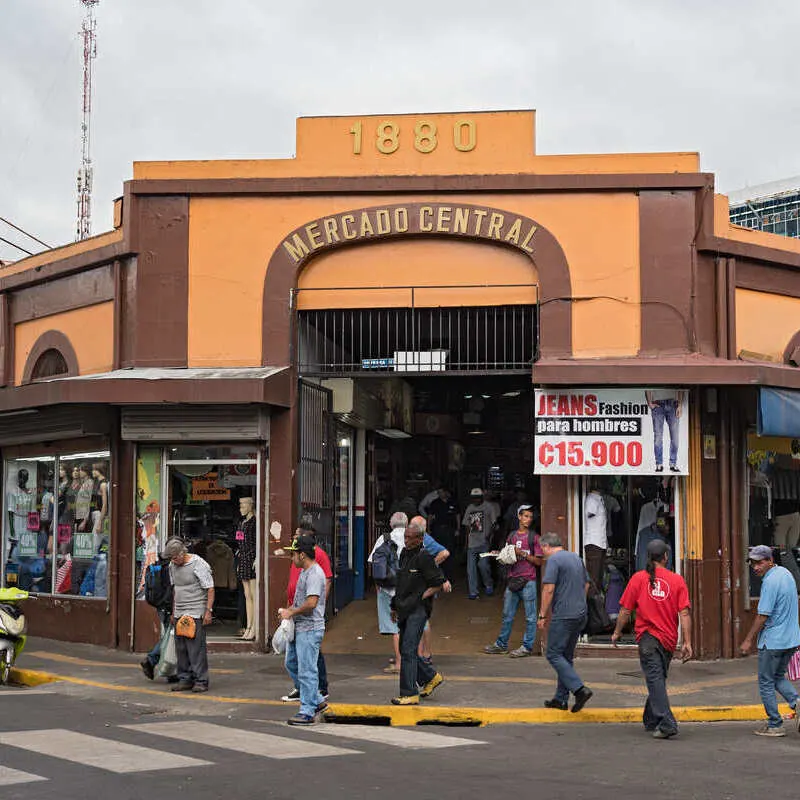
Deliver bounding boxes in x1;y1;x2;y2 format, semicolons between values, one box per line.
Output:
11;669;790;726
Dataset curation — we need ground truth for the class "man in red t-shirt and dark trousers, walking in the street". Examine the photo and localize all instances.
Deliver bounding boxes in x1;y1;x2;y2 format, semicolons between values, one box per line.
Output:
611;539;692;739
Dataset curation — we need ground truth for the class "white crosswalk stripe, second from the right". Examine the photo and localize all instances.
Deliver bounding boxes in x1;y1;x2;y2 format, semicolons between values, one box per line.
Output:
120;721;360;759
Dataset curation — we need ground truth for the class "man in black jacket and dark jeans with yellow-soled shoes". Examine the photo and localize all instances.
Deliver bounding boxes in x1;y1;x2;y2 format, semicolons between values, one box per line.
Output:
392;523;445;706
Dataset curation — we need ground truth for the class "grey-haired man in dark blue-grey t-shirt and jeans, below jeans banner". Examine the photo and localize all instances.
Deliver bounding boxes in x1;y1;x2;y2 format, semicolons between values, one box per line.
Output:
539;533;593;713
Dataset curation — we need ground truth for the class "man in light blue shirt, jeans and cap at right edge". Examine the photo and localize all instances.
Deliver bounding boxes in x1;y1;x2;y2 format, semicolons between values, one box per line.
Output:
739;544;800;736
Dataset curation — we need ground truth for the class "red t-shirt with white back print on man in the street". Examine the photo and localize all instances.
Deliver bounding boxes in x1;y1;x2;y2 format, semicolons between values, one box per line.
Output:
620;567;691;652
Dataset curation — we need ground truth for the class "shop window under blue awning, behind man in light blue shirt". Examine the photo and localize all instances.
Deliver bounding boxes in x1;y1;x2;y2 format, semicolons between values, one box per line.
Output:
745;432;800;597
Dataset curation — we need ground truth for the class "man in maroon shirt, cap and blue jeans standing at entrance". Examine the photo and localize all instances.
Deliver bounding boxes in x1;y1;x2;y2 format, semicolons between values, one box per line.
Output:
483;505;544;658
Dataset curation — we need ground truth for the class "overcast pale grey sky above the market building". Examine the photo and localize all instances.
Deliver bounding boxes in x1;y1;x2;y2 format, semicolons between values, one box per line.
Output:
0;0;800;259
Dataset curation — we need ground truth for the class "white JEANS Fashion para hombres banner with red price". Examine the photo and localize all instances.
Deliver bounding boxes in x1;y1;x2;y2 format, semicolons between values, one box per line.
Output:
534;388;689;475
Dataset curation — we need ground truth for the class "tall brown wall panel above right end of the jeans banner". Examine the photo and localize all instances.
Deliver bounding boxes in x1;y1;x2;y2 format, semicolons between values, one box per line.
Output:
639;192;696;355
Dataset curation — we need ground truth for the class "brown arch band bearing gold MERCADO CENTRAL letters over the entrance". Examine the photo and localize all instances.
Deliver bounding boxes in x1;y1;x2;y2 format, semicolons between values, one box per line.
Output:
261;202;572;366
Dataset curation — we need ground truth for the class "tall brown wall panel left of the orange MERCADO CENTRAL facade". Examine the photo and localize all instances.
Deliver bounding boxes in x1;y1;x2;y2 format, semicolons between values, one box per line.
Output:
134;197;189;367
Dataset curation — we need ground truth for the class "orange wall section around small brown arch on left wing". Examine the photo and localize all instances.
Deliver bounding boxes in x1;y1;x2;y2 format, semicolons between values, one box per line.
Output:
14;302;114;385
